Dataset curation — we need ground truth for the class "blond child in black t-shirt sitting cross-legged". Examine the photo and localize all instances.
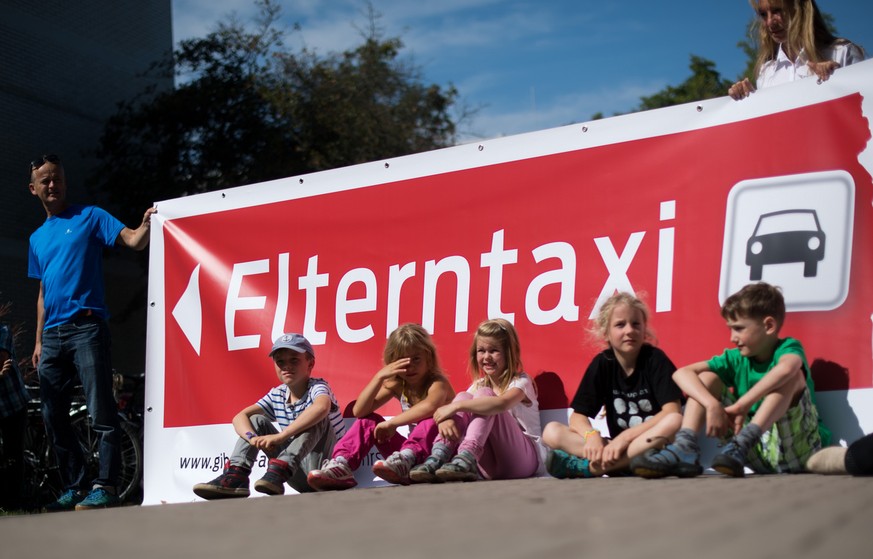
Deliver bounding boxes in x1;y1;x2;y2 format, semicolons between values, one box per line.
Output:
543;293;682;478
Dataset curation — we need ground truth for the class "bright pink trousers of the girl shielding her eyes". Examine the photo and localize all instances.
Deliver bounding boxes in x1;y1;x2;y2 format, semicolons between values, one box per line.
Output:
333;413;438;470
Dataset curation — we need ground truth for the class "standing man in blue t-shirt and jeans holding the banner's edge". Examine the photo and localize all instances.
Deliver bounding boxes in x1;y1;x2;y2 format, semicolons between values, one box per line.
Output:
27;155;156;511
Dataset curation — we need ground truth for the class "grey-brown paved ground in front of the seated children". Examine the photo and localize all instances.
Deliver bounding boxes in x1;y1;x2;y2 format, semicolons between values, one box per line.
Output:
0;474;873;559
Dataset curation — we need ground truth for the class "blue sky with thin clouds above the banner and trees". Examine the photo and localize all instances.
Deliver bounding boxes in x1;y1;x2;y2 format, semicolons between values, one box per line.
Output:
172;0;873;142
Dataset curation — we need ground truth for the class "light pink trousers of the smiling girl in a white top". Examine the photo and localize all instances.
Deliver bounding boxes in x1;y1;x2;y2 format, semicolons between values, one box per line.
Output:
436;388;540;479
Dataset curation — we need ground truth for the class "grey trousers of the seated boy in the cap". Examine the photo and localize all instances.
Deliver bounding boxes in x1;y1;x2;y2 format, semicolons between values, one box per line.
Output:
230;415;336;493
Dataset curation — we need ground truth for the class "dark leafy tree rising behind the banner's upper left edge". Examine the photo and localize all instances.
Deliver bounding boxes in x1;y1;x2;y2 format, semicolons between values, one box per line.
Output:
92;0;457;223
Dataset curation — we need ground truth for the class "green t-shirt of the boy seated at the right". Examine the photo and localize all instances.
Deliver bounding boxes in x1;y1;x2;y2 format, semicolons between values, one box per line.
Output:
707;338;831;446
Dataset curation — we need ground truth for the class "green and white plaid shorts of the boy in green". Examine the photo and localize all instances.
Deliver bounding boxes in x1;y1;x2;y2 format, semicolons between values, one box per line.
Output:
722;389;821;474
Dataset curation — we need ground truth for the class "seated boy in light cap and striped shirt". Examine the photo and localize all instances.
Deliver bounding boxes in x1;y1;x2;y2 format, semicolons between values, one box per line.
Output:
194;334;344;499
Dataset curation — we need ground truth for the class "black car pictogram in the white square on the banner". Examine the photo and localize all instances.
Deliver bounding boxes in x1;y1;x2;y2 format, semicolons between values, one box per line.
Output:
746;210;825;281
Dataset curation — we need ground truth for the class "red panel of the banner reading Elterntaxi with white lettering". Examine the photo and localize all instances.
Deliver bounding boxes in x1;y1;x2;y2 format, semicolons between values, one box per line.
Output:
158;94;873;427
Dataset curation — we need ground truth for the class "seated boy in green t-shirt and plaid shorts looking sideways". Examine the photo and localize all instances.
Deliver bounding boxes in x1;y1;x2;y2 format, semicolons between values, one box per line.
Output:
630;283;830;478
